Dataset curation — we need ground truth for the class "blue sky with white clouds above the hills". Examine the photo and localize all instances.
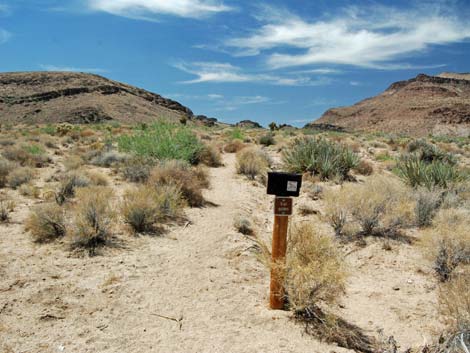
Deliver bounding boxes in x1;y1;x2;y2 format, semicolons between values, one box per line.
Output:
0;0;470;126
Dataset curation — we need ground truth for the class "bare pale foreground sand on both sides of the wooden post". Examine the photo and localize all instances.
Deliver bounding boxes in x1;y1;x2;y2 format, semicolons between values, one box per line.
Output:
0;155;436;353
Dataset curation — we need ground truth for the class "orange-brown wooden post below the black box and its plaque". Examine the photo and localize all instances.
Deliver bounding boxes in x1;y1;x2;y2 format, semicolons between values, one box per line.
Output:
269;215;289;309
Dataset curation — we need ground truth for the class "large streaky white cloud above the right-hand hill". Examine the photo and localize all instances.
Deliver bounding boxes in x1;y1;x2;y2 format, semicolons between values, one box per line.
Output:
225;3;470;69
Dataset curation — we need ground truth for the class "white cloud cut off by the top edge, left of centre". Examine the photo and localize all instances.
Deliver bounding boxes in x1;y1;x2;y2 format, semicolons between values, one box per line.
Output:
88;0;233;20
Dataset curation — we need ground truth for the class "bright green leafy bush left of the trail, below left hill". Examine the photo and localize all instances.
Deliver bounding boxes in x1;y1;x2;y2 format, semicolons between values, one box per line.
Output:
118;122;203;164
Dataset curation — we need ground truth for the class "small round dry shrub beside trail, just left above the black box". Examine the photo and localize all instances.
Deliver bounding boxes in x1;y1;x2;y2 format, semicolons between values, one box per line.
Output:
237;147;271;180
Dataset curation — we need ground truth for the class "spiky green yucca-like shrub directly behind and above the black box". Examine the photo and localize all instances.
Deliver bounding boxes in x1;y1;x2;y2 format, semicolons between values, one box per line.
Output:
283;137;359;180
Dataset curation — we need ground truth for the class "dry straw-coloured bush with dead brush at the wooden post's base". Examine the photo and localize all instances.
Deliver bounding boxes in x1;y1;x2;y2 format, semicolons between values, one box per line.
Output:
258;223;375;353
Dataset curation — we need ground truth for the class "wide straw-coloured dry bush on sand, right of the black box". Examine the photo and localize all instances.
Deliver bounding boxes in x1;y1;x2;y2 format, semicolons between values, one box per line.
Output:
325;176;415;235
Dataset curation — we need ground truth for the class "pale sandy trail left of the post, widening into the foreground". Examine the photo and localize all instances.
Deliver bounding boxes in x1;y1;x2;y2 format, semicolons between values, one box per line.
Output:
0;155;347;353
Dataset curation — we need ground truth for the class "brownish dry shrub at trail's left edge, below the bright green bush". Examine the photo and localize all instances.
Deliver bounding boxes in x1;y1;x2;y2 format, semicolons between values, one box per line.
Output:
148;160;209;207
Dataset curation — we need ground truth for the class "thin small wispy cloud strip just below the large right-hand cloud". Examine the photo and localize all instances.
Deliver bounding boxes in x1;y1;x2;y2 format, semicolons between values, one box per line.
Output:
174;62;330;86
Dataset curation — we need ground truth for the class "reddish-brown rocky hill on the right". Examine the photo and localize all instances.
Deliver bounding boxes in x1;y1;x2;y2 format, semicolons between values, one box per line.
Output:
307;72;470;136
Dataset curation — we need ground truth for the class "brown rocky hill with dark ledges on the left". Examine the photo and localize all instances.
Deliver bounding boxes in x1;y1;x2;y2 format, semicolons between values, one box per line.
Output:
0;72;193;124
